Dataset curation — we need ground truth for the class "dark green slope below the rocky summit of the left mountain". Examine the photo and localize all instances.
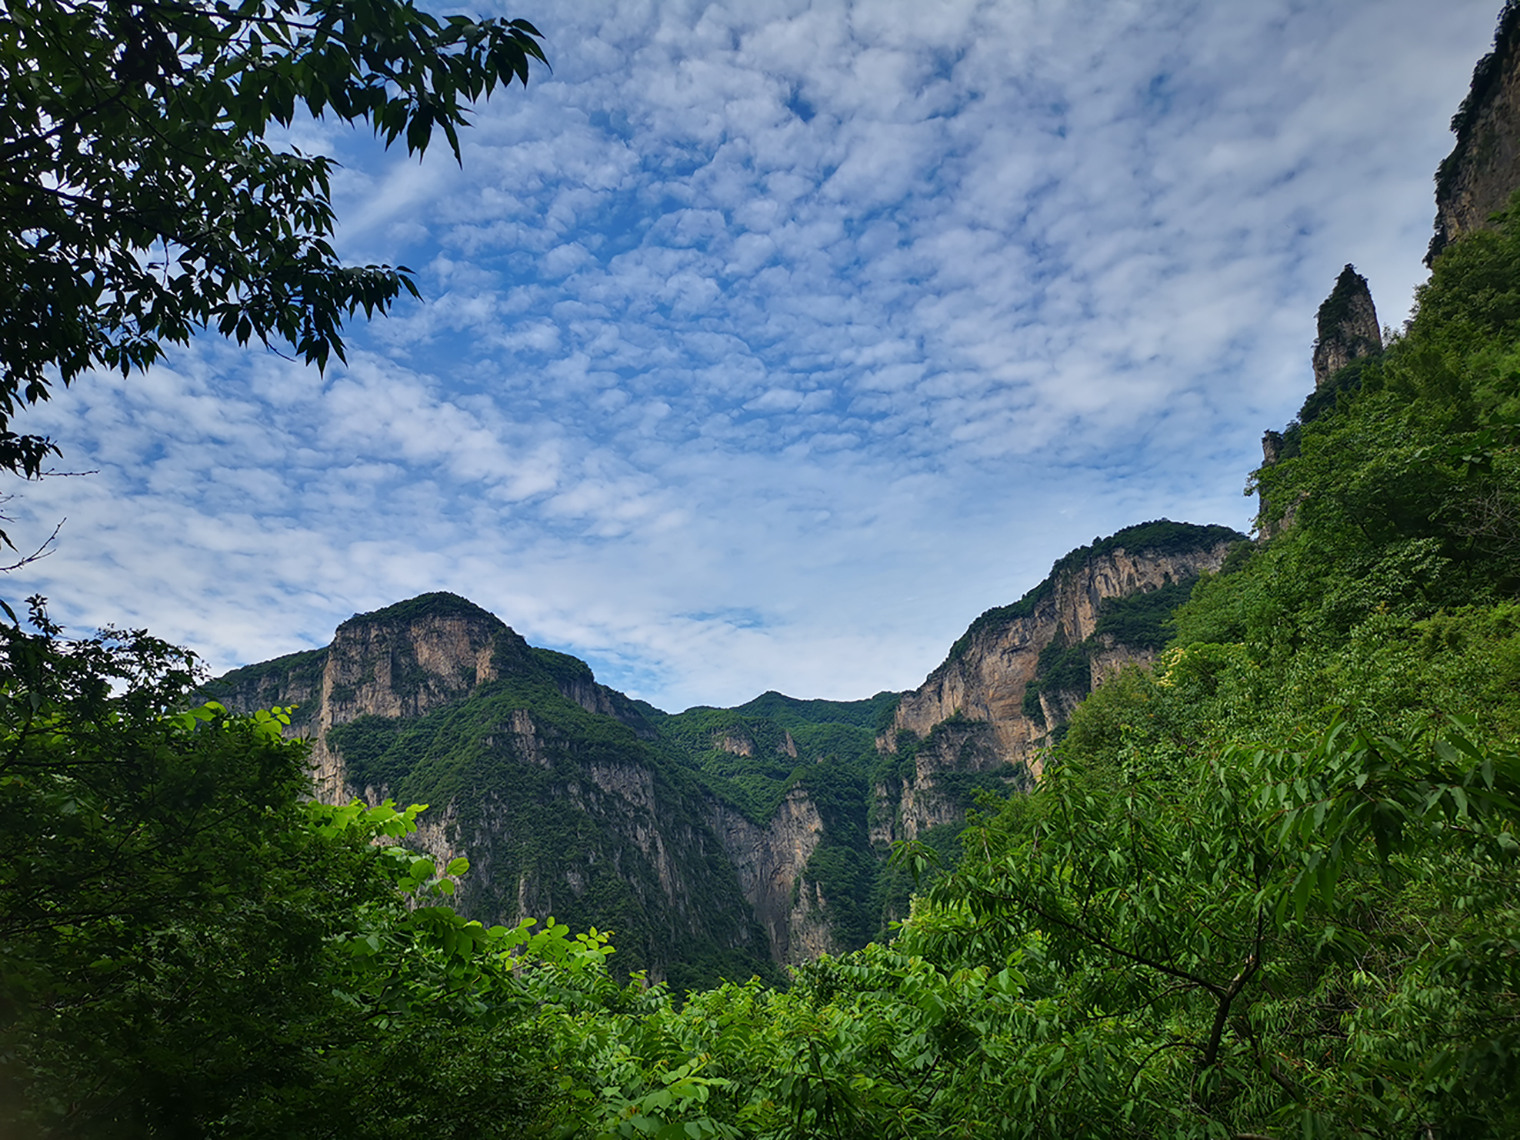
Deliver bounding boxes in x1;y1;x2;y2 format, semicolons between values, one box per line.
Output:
327;659;795;988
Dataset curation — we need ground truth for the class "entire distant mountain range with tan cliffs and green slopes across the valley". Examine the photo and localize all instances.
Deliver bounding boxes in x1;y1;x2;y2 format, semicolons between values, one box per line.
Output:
211;520;1243;988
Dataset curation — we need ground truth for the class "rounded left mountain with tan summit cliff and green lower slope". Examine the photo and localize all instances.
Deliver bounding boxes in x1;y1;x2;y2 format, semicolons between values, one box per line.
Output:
213;594;766;980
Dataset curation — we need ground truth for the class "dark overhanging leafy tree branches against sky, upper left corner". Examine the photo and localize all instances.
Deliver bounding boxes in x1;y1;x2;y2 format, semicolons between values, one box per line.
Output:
0;0;544;477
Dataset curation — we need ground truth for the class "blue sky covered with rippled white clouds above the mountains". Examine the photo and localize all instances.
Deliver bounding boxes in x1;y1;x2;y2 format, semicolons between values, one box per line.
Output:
0;0;1500;710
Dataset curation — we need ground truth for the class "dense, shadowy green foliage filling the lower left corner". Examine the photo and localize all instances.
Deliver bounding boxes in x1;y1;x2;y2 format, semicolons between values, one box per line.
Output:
0;605;606;1138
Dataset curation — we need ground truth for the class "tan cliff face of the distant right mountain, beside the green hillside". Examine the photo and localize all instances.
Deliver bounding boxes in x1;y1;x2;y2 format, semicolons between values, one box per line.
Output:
871;524;1242;844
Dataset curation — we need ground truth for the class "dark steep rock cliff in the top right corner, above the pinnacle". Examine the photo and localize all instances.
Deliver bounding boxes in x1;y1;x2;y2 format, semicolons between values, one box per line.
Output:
1426;0;1520;264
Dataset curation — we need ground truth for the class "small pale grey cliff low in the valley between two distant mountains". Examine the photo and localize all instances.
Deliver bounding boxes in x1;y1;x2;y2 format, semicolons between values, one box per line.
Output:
708;789;838;965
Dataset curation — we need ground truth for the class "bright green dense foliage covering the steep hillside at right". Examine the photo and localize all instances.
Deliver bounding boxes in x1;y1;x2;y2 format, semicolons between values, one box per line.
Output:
504;194;1520;1137
